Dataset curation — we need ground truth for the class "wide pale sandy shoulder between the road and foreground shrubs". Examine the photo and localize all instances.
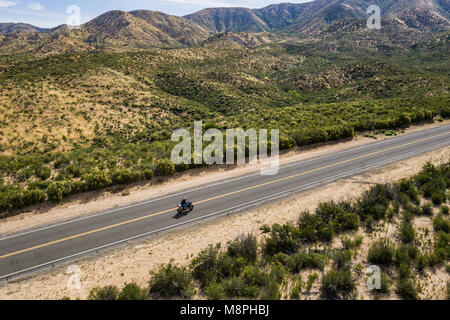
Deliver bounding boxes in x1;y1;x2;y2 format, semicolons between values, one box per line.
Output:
0;142;450;299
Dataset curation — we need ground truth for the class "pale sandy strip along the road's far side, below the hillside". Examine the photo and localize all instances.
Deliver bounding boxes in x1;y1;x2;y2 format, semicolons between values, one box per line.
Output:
0;120;450;236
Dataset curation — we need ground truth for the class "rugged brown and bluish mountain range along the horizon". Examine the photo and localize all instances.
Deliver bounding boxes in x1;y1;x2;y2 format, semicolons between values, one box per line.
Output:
0;0;450;54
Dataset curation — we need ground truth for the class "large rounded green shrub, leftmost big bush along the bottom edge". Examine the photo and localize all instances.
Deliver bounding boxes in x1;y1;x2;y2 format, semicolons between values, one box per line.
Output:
149;263;194;298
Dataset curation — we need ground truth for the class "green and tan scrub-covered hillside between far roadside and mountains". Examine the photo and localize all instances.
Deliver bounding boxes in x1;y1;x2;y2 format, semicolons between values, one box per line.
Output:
0;28;450;215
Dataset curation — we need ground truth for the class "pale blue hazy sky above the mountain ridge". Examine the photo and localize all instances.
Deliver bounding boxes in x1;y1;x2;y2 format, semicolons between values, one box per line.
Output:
0;0;311;27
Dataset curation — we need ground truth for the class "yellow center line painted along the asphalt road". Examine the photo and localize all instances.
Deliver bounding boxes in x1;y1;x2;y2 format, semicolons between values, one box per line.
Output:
0;132;450;259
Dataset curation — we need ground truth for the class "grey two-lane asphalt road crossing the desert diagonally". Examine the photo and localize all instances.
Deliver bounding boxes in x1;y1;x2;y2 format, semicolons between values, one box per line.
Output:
0;125;450;280
